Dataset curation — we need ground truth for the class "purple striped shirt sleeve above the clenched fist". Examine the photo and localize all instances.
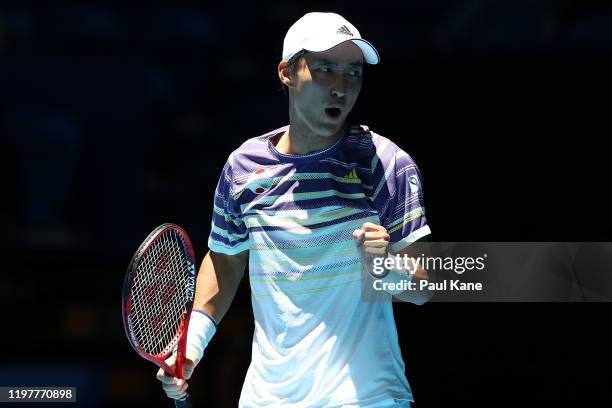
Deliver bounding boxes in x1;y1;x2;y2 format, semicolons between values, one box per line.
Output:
374;145;431;253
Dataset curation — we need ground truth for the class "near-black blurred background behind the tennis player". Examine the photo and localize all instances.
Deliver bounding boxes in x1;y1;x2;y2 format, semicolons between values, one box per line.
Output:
0;0;612;408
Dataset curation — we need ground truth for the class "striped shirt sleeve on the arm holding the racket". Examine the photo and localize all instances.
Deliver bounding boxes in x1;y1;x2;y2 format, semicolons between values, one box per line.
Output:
208;160;249;255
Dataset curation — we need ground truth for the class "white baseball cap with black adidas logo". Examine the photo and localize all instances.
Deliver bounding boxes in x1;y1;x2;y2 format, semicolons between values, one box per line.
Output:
283;13;380;65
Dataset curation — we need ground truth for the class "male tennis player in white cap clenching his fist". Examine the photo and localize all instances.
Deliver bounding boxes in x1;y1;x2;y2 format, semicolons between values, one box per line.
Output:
158;13;430;407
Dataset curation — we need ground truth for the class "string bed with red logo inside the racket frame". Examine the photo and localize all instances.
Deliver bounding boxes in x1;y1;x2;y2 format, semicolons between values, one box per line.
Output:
131;230;187;357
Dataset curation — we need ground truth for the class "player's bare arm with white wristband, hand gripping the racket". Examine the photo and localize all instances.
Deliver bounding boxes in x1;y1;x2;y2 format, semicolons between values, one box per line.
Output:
157;247;249;399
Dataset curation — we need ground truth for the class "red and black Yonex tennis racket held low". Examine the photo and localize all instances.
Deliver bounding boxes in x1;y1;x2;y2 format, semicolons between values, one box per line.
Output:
122;224;196;407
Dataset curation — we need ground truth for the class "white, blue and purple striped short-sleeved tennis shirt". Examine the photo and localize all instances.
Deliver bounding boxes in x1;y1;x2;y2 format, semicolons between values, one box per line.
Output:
208;126;430;407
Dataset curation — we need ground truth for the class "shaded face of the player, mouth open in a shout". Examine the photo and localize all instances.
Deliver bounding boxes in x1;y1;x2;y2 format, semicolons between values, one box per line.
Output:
291;41;363;137
